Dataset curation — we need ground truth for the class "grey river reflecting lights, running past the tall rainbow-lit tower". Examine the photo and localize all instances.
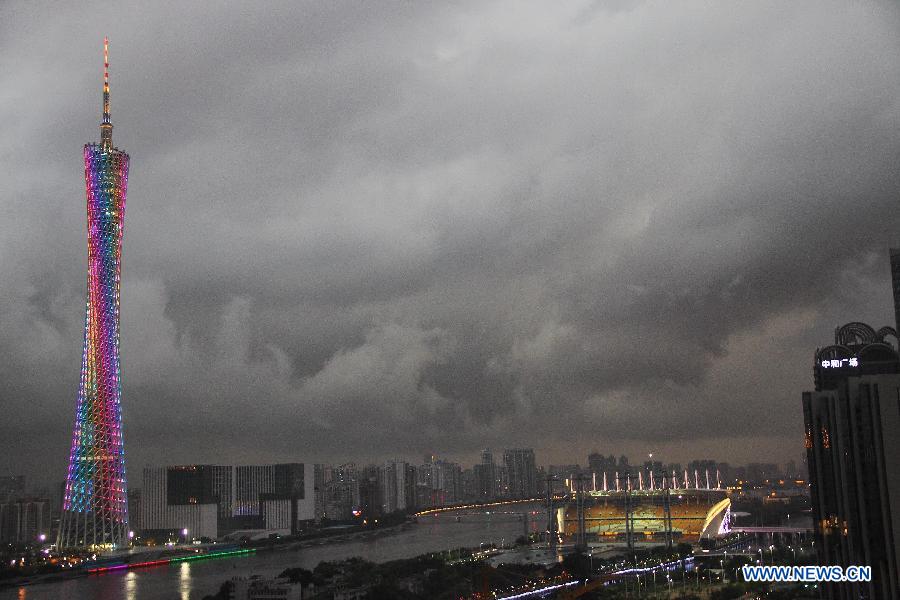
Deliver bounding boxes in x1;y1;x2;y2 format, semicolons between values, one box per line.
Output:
0;504;547;600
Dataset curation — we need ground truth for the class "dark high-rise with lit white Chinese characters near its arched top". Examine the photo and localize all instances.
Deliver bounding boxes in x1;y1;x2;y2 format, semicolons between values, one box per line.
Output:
803;323;900;599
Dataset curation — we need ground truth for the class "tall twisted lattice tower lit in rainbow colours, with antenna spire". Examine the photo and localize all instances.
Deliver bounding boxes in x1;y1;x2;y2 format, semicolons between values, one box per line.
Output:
57;38;128;548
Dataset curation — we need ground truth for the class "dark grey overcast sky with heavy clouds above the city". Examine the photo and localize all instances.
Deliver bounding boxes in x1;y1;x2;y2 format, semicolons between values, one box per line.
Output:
0;0;900;480
